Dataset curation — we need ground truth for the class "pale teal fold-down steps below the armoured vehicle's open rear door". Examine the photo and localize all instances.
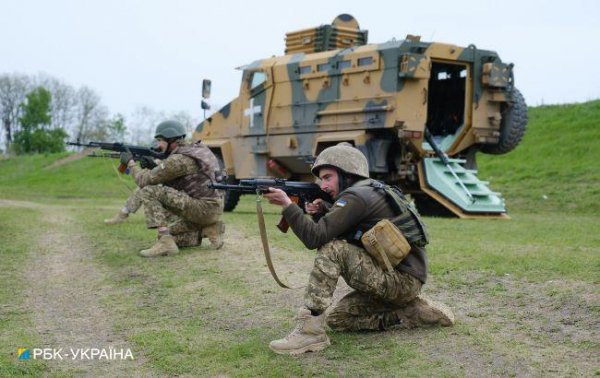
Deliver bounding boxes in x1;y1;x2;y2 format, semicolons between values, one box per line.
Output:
419;157;507;218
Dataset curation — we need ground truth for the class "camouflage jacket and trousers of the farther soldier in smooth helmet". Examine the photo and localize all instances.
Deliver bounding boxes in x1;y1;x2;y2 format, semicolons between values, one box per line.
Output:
131;142;223;247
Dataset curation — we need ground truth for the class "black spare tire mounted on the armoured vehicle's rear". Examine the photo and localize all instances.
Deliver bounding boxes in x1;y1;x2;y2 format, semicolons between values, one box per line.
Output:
481;88;527;155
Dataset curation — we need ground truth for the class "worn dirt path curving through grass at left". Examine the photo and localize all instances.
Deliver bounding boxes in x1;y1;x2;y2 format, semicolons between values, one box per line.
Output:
0;200;152;376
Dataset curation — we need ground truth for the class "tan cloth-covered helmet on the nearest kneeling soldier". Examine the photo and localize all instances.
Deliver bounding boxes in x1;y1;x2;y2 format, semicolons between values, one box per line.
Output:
311;142;369;178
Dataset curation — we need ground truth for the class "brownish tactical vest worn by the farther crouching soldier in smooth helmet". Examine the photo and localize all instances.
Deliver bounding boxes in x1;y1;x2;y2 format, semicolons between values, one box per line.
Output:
165;142;222;199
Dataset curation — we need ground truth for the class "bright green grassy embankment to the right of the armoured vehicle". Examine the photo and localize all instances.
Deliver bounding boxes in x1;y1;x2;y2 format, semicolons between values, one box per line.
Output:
478;100;600;215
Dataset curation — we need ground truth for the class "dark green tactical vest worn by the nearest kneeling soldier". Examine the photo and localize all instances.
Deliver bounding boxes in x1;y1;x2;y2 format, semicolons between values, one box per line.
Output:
346;179;429;247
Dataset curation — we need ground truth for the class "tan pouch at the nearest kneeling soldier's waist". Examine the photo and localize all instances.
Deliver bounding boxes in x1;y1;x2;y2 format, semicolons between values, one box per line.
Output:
360;219;411;273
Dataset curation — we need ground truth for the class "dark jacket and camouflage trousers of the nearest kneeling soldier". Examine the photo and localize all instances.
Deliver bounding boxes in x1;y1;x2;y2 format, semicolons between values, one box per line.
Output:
283;181;427;330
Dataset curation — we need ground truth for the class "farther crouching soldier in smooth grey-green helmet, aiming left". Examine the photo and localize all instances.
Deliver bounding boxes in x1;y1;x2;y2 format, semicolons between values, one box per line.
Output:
120;121;224;257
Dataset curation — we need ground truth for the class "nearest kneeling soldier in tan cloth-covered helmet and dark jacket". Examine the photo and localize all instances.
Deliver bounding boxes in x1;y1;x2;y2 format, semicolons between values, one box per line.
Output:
265;143;454;354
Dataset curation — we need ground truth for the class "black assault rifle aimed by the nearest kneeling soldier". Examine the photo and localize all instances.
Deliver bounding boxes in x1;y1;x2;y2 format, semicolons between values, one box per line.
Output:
208;178;333;232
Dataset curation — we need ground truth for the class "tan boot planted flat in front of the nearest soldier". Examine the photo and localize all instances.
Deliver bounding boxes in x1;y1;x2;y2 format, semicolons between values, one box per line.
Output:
269;308;331;355
